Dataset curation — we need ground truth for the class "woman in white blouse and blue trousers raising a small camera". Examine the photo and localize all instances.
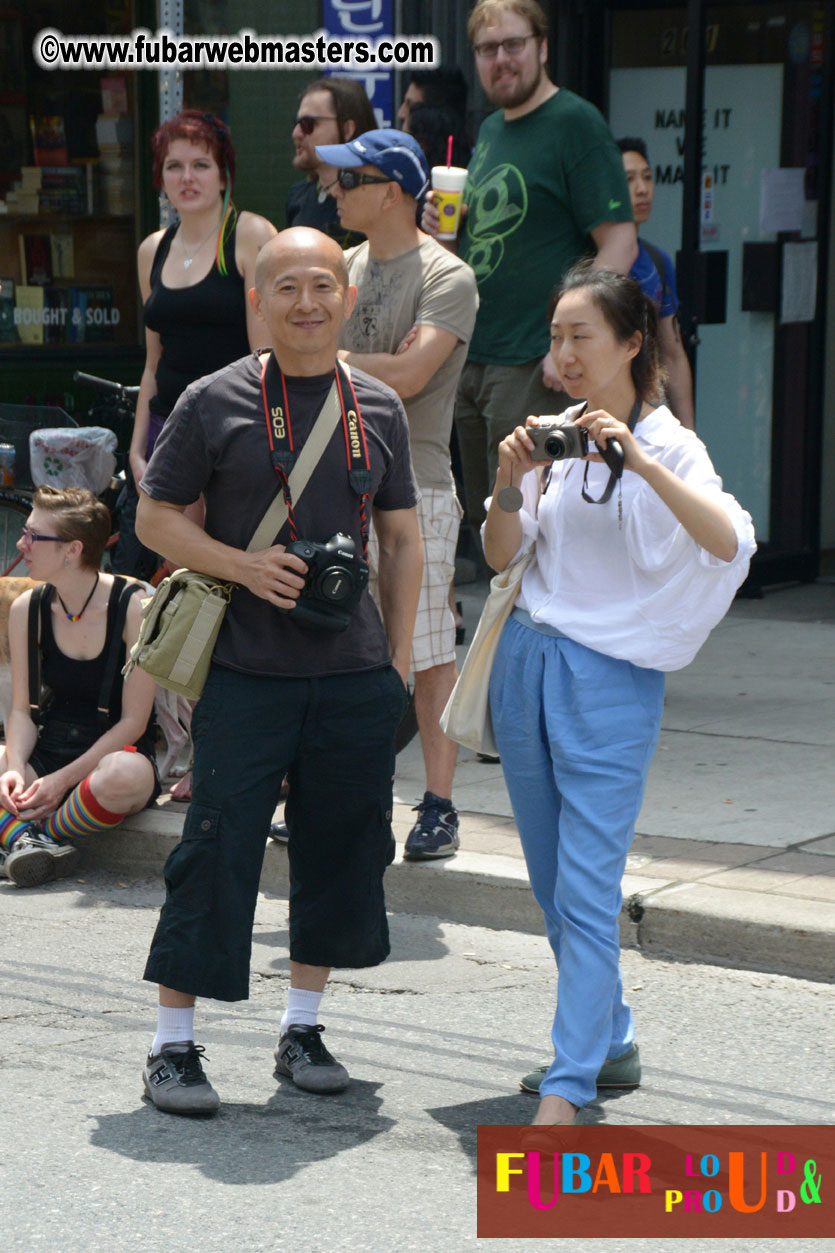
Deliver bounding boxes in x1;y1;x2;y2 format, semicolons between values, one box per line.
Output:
484;263;756;1124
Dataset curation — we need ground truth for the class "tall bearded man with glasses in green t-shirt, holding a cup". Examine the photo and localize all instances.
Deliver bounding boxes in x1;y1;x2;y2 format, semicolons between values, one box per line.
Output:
423;0;638;526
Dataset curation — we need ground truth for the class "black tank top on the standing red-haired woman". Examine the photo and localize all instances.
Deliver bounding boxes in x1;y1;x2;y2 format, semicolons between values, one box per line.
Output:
143;222;249;417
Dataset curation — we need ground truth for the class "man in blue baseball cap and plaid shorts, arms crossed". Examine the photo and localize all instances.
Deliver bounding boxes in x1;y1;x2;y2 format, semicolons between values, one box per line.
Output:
316;129;478;861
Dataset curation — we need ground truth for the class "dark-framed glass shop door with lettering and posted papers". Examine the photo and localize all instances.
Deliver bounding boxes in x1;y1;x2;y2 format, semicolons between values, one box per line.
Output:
608;3;824;576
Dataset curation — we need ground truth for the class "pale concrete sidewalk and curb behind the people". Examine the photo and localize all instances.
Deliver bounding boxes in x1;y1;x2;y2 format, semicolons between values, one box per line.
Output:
71;581;835;980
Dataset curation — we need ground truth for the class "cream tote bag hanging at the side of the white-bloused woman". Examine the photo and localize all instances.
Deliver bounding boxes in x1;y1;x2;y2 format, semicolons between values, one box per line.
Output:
440;548;534;757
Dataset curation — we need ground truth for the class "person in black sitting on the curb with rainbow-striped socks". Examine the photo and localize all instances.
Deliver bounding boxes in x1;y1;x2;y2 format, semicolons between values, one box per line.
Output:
0;487;160;887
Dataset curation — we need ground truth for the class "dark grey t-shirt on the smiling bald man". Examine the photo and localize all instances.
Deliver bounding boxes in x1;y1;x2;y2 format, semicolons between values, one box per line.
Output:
140;353;419;678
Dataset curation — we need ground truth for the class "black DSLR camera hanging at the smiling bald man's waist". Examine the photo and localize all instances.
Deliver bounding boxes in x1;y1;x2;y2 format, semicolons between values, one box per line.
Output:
285;533;369;630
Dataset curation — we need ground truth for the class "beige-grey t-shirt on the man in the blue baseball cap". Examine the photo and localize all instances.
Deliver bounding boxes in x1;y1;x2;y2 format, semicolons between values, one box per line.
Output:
340;237;479;489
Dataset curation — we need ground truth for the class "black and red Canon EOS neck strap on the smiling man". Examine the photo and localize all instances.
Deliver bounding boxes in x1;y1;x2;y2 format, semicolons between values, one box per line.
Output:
261;352;371;560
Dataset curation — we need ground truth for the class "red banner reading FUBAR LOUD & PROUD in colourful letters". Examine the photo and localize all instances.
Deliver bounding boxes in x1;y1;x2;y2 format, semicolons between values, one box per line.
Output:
478;1125;835;1239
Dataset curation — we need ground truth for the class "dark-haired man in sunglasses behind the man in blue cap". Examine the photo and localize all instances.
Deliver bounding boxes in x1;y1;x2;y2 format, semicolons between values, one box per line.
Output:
286;74;377;248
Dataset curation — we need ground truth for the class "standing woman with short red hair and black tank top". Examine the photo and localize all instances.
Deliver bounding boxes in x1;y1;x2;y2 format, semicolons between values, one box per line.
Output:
130;109;276;484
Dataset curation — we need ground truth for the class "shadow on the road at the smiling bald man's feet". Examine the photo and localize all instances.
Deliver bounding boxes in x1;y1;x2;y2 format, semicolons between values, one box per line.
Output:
90;1080;395;1185
